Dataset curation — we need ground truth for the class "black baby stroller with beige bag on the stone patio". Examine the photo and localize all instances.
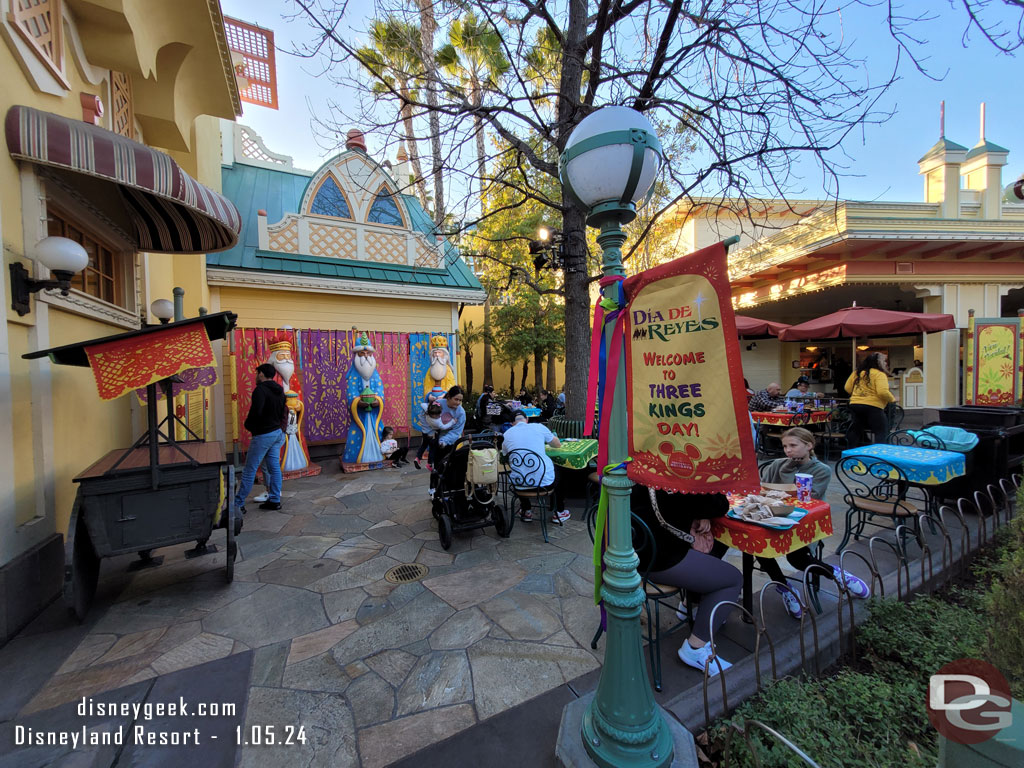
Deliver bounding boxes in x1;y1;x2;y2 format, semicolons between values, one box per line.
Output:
432;434;513;549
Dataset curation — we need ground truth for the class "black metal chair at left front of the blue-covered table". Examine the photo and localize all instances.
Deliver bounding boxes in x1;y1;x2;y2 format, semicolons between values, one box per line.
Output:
836;455;927;552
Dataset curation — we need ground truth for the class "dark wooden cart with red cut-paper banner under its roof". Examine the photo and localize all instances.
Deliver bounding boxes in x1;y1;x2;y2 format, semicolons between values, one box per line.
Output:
25;312;242;620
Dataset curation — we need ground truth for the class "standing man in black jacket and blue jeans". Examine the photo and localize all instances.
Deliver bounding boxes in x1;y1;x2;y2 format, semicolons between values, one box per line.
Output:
234;362;288;514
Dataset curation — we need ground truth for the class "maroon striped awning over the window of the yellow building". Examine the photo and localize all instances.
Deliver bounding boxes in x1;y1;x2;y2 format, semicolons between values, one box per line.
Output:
5;105;242;253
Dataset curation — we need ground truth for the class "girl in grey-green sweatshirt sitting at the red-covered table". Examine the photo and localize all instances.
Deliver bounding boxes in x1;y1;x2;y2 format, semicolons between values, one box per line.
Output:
758;427;871;618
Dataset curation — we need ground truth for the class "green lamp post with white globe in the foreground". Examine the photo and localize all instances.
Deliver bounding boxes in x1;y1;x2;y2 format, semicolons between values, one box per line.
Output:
558;106;695;768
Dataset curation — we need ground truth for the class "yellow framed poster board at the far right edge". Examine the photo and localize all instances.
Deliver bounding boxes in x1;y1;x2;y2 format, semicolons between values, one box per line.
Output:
964;314;1024;406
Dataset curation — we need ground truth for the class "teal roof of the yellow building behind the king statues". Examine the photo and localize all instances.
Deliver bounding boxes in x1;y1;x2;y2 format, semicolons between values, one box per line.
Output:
206;163;482;291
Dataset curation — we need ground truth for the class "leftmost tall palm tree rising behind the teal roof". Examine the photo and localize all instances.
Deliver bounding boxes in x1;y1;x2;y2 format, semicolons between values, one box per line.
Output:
358;16;430;210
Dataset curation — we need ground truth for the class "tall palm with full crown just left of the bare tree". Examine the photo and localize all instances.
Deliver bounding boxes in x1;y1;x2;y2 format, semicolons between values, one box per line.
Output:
437;12;510;385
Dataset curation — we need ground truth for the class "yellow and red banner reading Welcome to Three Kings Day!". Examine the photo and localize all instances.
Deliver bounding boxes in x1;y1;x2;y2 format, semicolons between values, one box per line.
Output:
625;244;760;494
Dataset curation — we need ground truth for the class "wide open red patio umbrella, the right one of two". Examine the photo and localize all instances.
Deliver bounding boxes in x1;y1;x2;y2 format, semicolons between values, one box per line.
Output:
778;305;956;341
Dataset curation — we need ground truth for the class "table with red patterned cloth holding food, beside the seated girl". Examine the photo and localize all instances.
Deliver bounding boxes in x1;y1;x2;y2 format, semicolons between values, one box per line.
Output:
711;499;833;614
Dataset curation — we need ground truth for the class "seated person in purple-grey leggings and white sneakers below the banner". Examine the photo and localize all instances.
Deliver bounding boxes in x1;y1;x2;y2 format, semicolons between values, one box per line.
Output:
630;485;743;675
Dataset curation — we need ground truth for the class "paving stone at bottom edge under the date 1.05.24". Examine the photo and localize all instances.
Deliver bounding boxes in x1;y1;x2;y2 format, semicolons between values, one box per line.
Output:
240;688;359;768
